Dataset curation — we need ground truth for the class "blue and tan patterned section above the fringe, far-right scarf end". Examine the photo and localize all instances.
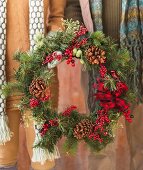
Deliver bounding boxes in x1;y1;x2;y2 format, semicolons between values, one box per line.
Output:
120;0;143;42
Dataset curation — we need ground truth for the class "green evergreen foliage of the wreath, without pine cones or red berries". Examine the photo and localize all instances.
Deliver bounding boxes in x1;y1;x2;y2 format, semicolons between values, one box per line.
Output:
2;20;137;154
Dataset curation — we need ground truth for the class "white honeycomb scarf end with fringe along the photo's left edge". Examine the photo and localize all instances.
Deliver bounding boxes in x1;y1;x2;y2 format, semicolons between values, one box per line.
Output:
0;0;12;144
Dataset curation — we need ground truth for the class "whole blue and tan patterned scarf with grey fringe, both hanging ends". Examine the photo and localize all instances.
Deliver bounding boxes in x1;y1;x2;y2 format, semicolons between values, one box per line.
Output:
88;0;143;112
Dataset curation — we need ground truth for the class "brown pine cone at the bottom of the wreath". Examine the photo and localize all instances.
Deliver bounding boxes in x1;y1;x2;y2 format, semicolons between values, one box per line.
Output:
73;119;93;139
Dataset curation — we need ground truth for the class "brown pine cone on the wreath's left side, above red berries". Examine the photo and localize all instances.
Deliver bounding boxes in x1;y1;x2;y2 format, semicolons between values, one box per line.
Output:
29;78;46;98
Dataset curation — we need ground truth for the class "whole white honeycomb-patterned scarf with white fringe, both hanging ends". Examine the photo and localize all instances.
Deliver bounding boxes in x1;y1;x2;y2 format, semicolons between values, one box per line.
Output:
0;0;60;163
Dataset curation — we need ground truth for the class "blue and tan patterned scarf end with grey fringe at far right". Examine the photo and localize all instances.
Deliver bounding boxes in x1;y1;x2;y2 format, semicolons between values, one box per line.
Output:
120;0;143;98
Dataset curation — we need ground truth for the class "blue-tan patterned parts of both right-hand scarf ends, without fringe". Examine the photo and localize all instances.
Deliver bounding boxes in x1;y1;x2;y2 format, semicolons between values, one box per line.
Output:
89;0;143;41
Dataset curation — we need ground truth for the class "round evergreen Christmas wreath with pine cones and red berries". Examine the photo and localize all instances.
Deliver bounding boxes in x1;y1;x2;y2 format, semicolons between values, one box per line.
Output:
3;20;136;161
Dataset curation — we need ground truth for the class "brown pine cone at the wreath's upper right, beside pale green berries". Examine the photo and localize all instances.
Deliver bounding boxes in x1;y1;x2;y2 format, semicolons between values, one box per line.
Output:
85;46;106;64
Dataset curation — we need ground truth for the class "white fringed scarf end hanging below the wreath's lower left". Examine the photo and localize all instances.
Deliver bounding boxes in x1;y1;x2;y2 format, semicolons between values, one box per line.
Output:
32;123;60;164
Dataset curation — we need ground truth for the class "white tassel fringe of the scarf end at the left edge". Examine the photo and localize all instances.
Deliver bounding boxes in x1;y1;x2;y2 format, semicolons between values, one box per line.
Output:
0;114;12;145
